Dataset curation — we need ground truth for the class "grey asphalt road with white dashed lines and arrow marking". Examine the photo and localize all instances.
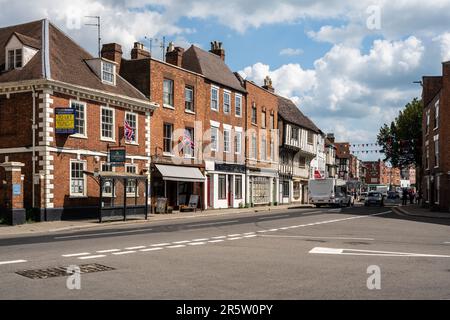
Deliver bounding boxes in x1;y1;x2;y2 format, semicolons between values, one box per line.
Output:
0;206;450;300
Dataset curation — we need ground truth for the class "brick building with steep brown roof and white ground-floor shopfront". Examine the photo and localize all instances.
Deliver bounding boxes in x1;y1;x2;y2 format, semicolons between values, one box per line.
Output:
182;41;247;209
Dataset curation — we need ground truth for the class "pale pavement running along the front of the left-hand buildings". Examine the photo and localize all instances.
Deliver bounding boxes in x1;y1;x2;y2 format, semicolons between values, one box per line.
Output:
0;204;312;237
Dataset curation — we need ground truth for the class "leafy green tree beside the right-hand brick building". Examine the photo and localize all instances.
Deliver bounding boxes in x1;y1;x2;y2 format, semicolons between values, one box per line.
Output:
377;98;423;185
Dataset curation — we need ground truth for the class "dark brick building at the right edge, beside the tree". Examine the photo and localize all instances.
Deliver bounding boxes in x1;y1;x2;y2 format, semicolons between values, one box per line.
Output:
421;62;450;211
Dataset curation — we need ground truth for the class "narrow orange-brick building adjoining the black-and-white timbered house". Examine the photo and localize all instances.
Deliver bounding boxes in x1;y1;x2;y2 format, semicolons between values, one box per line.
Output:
244;77;278;205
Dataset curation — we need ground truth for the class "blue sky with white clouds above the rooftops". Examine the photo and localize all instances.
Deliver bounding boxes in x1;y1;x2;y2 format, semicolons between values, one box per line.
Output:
0;0;450;160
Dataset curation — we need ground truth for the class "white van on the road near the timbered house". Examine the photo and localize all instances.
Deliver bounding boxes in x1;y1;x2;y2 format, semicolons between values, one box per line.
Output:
308;178;354;207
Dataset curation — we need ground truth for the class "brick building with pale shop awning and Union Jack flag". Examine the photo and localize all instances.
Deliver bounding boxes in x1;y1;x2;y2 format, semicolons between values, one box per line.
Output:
117;43;209;210
